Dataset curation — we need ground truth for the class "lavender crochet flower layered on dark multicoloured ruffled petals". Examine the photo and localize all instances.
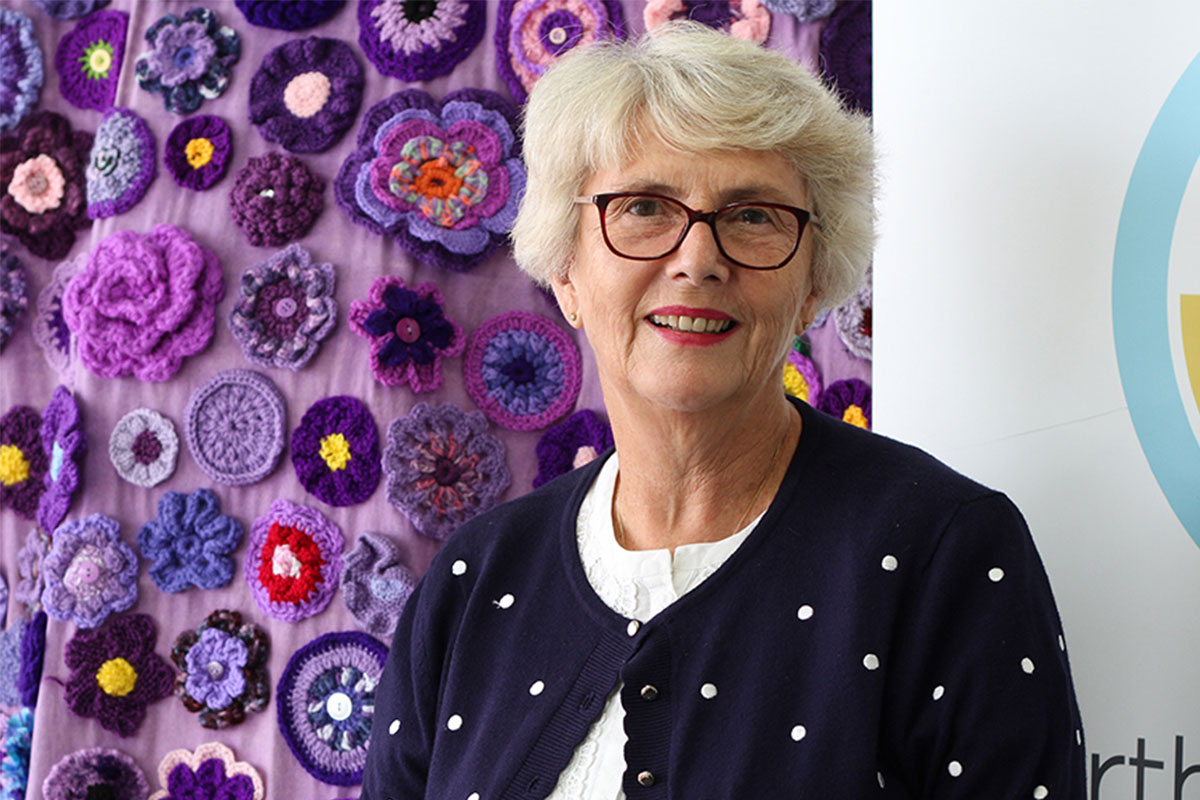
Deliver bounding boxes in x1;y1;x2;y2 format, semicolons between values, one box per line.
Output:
170;610;271;729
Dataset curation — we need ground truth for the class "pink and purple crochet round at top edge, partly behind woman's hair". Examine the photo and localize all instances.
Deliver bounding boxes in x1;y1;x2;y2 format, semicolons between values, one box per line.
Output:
496;0;625;103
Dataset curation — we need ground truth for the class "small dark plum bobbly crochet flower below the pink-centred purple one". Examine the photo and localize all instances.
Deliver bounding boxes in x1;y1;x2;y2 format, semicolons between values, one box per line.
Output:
229;152;325;247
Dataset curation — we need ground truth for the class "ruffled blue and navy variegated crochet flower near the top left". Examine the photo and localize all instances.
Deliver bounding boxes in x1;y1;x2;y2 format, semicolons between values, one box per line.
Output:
133;7;241;114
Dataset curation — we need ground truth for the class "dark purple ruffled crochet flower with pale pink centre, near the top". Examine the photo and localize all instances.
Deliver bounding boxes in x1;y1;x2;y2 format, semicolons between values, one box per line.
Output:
250;36;364;152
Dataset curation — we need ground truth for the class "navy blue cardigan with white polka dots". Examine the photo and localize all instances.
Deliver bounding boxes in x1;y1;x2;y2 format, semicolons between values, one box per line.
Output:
362;404;1085;800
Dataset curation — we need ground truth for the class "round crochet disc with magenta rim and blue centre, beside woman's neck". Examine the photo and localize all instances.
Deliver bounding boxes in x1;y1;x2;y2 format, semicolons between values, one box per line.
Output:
462;311;583;431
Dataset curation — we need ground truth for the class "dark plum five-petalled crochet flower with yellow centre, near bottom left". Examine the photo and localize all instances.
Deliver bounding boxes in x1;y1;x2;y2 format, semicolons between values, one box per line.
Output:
64;614;175;736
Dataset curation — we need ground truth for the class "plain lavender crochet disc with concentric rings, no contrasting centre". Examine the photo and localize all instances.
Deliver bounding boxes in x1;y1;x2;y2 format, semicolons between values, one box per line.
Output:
184;369;287;486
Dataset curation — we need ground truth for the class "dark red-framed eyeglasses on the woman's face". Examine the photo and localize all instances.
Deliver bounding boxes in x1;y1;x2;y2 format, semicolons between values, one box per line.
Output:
575;192;816;270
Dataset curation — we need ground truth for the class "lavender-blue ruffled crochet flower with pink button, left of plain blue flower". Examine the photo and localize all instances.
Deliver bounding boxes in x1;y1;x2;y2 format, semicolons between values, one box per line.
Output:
42;513;138;627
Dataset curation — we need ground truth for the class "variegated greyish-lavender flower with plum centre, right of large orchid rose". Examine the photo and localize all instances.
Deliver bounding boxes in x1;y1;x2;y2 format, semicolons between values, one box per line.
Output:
229;243;337;369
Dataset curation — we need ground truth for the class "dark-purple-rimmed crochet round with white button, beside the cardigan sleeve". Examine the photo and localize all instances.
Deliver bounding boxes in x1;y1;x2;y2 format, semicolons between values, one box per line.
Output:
275;631;388;786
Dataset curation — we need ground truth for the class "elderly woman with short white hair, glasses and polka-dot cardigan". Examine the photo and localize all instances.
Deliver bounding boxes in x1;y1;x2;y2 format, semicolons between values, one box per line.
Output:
362;25;1085;800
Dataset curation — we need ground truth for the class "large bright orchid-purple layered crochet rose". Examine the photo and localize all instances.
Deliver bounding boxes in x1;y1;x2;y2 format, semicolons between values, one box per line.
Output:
62;224;224;380
